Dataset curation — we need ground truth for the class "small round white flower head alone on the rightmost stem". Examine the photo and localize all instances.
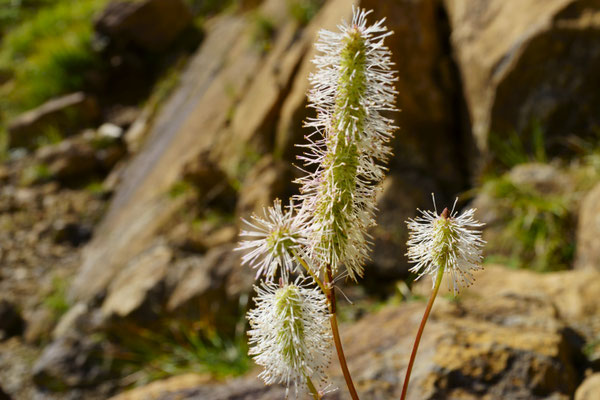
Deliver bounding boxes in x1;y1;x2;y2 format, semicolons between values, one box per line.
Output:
407;199;485;294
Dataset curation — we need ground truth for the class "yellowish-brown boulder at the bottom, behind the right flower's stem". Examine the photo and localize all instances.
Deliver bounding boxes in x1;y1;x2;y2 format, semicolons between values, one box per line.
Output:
109;266;600;400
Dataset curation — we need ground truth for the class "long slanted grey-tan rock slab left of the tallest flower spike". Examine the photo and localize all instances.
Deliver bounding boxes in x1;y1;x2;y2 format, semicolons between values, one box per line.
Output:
71;0;294;301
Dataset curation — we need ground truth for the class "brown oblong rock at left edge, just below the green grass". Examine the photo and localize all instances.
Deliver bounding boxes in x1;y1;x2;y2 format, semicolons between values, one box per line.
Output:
8;92;100;148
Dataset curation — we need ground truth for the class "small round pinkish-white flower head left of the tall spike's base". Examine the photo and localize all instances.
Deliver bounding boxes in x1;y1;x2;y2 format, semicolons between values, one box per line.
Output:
236;199;307;280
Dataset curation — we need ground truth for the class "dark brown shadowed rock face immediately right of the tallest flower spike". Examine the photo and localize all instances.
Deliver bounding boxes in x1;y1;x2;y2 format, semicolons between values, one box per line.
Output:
360;0;473;193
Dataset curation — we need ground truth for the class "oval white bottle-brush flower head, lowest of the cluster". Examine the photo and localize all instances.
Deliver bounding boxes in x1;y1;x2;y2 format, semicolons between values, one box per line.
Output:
247;278;332;393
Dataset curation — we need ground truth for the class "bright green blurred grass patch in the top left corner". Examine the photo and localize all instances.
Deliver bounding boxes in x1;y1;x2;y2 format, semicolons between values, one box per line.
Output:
0;0;107;115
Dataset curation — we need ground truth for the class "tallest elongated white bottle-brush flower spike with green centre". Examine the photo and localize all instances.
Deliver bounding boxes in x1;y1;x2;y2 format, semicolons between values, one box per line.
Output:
298;9;396;280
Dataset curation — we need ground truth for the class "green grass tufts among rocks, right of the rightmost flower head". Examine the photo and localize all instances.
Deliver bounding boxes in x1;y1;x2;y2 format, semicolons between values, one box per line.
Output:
477;124;600;271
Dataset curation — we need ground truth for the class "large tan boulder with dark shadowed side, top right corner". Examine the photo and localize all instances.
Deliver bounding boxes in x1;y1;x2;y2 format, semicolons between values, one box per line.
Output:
445;0;600;152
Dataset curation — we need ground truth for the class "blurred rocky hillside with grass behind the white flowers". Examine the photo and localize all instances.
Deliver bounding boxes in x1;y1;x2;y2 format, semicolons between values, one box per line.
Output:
0;0;600;400
